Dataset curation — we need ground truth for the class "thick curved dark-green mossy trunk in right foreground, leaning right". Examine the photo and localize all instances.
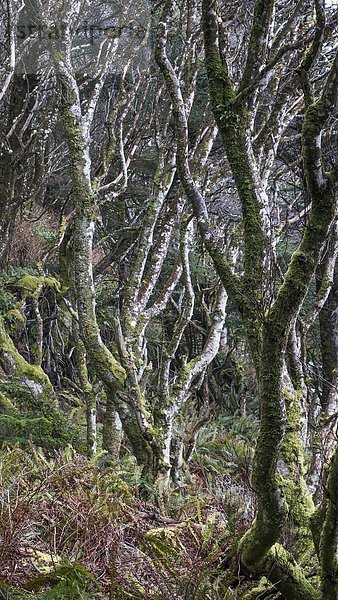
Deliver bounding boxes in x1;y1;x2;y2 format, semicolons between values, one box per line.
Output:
240;102;335;598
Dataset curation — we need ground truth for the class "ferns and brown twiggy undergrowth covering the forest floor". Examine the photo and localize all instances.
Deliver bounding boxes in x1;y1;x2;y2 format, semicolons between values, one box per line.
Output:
0;423;262;600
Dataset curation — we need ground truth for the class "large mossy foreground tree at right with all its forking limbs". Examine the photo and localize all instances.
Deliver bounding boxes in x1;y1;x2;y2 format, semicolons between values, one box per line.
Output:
156;0;338;598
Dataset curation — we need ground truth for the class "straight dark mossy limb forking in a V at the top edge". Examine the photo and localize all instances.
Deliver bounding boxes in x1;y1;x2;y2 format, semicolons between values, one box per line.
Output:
203;0;264;371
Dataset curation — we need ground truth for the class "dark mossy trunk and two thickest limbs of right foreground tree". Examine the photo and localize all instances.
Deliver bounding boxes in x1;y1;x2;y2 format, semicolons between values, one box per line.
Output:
203;0;338;600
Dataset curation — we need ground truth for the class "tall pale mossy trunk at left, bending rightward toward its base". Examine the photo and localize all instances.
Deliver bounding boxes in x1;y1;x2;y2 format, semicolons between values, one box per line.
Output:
51;16;156;472
